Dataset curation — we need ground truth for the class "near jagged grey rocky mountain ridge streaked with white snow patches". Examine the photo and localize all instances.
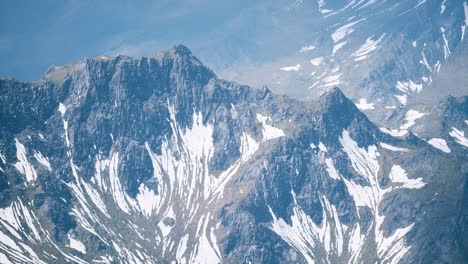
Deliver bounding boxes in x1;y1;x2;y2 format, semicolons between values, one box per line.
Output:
0;46;468;263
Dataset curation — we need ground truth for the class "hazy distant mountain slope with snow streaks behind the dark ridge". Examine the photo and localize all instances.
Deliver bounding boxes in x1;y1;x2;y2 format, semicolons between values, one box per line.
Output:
210;0;468;127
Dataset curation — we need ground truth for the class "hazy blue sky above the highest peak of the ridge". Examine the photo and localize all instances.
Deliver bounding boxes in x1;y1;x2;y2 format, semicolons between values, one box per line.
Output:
0;0;251;81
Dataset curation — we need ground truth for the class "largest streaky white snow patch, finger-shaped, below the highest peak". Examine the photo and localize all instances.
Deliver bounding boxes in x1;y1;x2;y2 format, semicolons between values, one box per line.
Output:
136;103;264;250
